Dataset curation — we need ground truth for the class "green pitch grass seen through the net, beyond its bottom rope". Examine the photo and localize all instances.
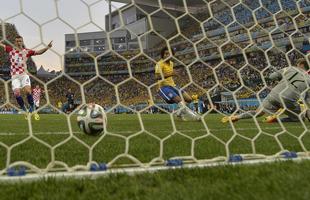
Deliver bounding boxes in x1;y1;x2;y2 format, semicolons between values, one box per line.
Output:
0;114;310;169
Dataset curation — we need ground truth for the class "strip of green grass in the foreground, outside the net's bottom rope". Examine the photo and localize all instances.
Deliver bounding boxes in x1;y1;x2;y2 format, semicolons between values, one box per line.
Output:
0;161;310;200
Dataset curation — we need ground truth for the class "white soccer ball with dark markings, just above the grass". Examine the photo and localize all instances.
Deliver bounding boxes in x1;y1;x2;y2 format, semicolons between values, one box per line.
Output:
77;103;107;135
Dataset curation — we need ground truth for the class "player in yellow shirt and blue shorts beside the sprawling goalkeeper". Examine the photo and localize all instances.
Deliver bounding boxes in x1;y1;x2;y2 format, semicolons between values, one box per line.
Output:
155;47;200;120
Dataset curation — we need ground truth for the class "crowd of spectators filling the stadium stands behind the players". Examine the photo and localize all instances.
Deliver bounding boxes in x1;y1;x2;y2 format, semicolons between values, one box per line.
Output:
0;0;310;113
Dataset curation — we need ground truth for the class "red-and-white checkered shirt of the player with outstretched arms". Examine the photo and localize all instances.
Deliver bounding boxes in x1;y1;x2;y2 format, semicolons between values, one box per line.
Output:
5;45;35;76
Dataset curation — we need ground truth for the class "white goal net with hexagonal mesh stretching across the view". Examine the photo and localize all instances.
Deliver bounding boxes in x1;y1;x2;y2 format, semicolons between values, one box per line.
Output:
0;0;310;178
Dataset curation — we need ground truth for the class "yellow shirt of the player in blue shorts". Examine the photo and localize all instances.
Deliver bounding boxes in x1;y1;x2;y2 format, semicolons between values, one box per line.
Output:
155;59;175;88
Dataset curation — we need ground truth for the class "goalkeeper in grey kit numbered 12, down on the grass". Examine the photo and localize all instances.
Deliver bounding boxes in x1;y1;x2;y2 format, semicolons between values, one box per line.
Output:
222;59;310;123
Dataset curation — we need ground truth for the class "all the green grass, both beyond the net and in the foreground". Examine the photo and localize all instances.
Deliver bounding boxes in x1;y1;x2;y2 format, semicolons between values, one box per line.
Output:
0;114;310;199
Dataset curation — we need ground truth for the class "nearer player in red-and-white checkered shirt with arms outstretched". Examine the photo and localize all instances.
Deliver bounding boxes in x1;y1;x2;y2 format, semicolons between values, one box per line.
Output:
0;36;52;120
